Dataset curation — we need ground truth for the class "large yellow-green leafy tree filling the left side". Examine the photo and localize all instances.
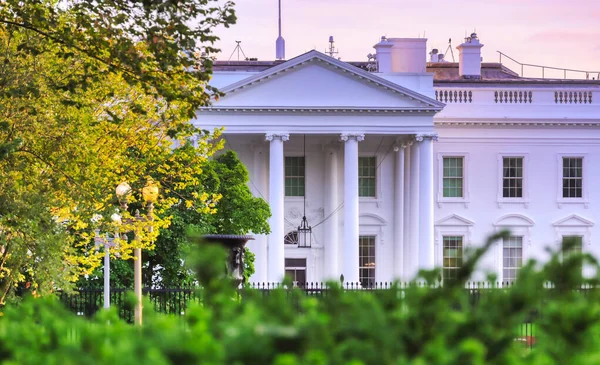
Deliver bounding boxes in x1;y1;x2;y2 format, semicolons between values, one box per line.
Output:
0;0;235;305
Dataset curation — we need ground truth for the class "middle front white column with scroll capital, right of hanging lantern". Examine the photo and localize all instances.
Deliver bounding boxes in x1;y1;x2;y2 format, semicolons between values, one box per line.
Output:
341;134;365;285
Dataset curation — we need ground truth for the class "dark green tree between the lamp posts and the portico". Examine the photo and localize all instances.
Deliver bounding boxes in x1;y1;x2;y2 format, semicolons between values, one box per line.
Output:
80;150;271;287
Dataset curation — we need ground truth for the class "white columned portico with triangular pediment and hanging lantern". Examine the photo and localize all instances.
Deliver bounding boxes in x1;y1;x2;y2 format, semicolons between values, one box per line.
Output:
194;51;443;283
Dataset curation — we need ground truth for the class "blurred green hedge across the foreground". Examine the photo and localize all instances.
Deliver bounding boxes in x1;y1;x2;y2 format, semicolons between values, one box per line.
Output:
0;235;600;365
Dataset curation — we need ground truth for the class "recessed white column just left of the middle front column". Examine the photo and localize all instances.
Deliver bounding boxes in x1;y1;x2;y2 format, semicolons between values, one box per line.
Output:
323;146;340;280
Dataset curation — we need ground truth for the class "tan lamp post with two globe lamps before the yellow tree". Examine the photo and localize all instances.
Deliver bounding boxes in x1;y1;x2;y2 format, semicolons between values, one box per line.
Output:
115;180;158;325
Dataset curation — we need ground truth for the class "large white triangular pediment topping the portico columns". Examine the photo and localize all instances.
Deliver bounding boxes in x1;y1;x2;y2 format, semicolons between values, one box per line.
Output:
212;51;444;111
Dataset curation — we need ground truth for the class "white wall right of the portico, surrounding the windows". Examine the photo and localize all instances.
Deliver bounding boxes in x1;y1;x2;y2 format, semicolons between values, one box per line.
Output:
434;128;600;280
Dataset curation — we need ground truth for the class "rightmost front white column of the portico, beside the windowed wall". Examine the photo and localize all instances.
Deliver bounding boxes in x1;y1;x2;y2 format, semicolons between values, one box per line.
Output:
415;134;437;269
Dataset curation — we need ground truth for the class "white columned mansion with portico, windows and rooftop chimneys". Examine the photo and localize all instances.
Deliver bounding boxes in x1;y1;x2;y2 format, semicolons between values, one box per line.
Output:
194;34;600;285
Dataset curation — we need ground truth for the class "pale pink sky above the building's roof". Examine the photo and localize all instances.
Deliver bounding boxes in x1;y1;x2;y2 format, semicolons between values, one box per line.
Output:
217;0;600;76
